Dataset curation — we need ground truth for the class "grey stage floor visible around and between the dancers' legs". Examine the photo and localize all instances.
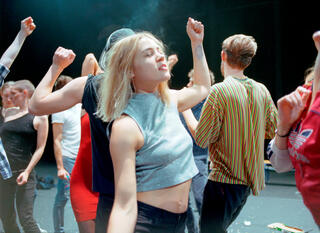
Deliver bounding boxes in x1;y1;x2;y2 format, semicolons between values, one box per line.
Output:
0;163;319;233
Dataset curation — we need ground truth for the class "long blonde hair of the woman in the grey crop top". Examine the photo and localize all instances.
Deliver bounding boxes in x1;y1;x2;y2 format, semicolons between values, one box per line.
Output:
97;32;170;122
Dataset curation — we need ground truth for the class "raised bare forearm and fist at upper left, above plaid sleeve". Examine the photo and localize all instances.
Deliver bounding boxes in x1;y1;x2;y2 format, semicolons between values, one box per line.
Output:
0;17;36;69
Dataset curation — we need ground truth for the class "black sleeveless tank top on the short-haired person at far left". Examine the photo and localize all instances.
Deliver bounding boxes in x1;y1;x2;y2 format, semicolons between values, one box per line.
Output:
0;113;37;172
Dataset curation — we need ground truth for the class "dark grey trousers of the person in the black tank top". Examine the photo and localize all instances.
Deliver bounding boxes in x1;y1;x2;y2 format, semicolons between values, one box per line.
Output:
0;171;40;233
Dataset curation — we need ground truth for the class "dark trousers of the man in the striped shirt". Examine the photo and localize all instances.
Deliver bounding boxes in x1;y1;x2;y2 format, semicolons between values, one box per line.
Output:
200;180;250;233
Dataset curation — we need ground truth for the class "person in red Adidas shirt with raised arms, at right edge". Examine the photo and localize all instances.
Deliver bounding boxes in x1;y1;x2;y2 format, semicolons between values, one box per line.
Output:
268;31;320;228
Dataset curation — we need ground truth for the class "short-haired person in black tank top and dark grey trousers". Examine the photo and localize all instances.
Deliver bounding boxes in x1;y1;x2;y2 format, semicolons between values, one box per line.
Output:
0;80;48;233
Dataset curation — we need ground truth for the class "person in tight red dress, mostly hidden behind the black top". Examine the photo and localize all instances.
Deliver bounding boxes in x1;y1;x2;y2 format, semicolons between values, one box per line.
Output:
70;53;103;233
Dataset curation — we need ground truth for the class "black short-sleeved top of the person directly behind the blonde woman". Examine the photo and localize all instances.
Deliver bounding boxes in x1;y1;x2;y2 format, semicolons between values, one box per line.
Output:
82;74;114;196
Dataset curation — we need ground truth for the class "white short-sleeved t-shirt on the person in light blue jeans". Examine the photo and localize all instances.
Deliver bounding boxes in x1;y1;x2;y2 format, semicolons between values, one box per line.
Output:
51;104;81;159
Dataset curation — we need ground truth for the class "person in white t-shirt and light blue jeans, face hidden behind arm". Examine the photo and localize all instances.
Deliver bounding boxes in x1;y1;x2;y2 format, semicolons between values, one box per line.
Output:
51;75;81;233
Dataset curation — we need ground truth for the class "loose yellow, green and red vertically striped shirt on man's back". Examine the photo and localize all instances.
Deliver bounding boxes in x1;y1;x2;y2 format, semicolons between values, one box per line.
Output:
196;76;278;195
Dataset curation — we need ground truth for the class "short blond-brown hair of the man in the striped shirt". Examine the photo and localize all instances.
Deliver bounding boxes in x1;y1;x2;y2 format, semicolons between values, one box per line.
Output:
222;34;258;69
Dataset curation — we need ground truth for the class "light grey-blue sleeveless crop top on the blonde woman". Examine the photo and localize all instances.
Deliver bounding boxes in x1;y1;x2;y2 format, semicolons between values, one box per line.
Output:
124;93;198;192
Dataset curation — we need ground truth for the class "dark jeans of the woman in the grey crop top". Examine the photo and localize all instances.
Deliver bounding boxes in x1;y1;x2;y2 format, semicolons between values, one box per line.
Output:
134;202;187;233
